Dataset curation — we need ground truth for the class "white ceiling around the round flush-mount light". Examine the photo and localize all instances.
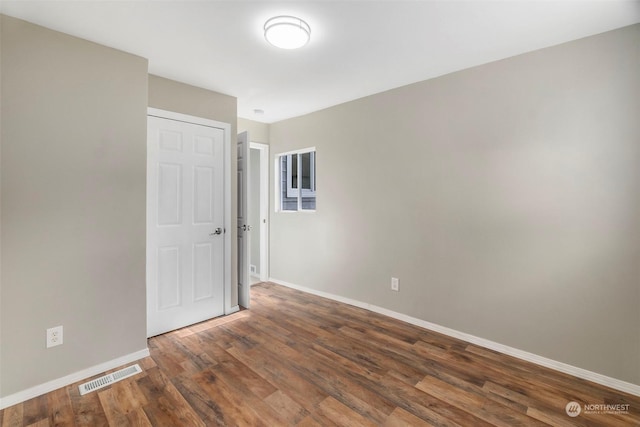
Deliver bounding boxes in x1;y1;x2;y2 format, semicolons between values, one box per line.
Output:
0;0;640;123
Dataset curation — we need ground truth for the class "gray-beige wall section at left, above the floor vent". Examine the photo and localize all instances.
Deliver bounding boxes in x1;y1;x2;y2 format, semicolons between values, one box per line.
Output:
0;16;147;396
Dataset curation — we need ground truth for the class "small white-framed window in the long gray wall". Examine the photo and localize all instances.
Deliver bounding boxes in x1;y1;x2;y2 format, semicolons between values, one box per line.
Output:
276;148;316;211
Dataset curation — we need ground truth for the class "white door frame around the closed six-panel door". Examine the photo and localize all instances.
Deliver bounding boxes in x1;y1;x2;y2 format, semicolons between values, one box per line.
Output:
147;107;240;314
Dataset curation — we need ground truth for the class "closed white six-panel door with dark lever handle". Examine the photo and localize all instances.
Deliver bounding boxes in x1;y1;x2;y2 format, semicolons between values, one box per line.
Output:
147;116;225;336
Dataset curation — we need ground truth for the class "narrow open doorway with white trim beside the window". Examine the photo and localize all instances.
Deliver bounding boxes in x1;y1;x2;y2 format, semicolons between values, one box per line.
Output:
249;142;269;284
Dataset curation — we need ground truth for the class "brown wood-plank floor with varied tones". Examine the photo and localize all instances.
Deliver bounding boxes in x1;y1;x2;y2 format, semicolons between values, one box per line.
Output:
0;283;640;427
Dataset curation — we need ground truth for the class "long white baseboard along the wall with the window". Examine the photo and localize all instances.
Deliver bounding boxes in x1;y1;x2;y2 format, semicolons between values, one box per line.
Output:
269;277;640;396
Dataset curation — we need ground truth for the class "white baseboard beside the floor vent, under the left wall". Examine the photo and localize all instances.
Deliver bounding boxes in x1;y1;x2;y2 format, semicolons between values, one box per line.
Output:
0;348;149;410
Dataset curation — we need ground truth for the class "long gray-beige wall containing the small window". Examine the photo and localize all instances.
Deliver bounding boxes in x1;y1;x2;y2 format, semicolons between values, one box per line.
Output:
270;25;640;384
